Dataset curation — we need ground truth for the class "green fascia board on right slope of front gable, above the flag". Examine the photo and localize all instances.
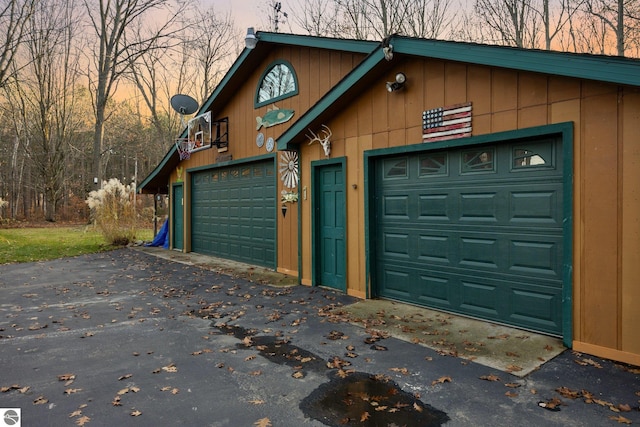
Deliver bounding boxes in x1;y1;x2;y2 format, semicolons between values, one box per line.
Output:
391;37;640;86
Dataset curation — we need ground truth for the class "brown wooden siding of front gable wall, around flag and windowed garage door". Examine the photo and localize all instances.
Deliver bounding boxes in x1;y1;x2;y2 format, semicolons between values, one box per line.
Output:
300;59;640;364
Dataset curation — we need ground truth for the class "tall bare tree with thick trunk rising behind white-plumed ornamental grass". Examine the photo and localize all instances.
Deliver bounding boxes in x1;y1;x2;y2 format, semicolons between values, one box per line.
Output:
84;0;185;189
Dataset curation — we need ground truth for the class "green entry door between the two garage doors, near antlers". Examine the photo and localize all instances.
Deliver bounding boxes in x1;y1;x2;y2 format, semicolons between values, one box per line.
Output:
313;164;346;291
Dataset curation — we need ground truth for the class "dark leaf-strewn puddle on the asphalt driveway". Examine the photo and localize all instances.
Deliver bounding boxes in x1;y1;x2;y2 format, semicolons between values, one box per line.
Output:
215;325;449;427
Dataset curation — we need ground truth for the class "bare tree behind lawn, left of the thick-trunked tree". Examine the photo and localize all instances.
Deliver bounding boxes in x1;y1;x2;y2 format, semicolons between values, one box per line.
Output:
17;0;79;221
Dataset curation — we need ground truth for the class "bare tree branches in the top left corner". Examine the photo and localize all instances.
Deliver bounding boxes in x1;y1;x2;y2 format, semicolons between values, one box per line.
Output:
0;0;38;87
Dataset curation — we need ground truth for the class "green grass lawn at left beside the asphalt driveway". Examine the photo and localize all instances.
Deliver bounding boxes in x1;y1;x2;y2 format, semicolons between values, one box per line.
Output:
0;226;153;264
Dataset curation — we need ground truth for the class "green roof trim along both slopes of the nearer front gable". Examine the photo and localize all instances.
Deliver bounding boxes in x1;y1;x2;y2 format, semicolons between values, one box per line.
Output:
277;36;640;150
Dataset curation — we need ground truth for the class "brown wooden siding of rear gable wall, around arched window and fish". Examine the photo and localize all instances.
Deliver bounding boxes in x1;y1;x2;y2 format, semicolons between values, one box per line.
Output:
171;46;363;275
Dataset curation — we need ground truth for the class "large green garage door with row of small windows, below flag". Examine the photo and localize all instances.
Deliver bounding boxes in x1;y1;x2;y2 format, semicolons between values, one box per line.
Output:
373;139;563;335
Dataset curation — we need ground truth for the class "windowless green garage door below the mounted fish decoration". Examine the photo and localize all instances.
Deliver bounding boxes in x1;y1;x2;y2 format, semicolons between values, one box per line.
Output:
191;160;276;268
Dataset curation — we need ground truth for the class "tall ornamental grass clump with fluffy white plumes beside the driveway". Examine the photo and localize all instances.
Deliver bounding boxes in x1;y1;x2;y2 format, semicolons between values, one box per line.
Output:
85;178;137;246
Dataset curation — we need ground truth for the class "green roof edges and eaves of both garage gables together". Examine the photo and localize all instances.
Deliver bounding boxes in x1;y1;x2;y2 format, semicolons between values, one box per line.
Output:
138;32;640;194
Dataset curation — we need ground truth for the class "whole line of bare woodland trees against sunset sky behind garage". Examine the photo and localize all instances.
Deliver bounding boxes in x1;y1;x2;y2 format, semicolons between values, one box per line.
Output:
0;0;640;226
